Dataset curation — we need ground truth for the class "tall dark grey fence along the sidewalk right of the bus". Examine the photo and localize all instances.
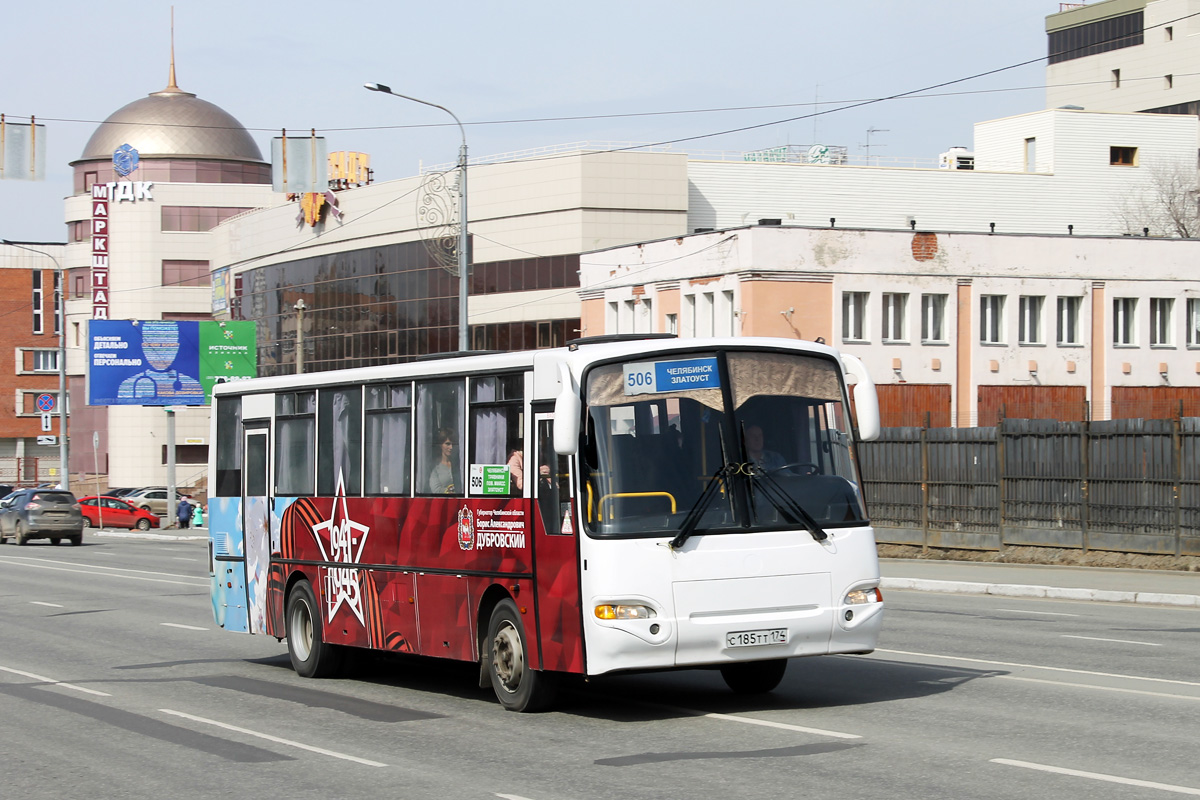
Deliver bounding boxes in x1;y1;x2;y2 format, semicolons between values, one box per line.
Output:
859;417;1200;555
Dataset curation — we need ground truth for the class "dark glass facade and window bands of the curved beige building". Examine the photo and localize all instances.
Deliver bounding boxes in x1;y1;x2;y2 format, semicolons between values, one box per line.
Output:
232;242;580;375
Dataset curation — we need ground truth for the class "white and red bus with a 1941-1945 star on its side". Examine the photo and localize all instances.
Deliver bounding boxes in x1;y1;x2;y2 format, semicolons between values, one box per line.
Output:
209;337;883;711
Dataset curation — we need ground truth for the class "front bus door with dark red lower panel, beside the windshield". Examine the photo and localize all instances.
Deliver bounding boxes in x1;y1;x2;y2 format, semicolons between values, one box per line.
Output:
526;403;583;673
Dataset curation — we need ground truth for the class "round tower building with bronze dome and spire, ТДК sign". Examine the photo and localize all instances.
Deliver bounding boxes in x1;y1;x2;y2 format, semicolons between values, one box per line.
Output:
64;65;283;487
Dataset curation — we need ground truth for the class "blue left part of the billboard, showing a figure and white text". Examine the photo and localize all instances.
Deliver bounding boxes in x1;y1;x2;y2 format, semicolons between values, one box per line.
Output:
88;319;206;405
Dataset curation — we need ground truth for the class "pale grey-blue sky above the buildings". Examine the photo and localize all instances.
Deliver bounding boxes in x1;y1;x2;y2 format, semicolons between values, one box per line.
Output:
0;0;1058;241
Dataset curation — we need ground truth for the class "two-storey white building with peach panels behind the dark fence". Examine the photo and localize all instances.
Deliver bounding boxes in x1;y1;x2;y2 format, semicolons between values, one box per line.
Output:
580;225;1200;427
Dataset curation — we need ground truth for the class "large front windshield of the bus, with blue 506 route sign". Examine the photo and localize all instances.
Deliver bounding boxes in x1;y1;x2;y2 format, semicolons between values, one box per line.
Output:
582;350;866;539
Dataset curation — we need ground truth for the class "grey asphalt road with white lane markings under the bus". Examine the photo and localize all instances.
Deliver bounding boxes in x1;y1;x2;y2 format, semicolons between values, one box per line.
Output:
0;535;1200;800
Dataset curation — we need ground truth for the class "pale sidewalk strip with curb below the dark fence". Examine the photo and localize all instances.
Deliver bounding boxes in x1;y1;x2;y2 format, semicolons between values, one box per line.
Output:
880;559;1200;608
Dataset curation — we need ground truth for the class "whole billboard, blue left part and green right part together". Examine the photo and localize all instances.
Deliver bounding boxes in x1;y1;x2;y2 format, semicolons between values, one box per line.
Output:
88;319;258;405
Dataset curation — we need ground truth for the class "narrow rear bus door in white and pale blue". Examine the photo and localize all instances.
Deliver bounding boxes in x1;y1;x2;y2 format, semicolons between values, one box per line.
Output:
241;422;271;633
